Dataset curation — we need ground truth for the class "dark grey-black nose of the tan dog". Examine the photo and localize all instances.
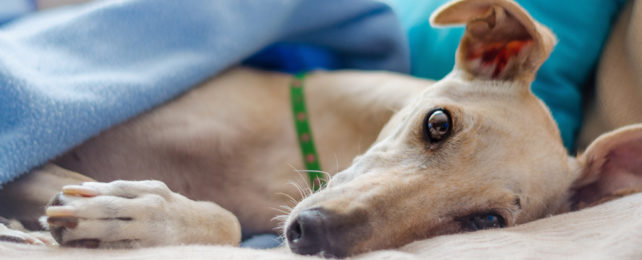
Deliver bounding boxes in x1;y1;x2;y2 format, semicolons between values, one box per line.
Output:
285;208;347;257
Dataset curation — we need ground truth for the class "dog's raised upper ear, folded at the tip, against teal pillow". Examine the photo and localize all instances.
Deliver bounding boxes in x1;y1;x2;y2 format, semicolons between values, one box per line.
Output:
430;0;557;83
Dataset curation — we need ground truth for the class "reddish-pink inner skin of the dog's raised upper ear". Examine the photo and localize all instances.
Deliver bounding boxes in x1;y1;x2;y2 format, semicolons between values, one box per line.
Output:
466;40;533;78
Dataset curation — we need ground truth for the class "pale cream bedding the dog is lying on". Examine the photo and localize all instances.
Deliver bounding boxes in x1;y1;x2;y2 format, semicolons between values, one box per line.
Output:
0;194;642;260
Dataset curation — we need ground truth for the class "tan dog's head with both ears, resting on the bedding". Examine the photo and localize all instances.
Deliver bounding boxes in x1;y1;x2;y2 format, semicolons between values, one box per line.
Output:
285;0;642;257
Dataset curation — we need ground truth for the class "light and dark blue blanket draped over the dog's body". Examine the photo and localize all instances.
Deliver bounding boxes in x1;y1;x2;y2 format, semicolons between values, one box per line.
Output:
0;0;409;185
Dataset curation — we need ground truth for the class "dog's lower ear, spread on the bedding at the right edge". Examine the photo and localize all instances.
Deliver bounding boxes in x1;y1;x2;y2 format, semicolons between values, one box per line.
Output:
571;124;642;209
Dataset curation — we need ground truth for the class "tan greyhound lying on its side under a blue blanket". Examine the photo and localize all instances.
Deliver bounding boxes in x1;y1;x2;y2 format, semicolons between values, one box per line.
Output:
1;0;642;257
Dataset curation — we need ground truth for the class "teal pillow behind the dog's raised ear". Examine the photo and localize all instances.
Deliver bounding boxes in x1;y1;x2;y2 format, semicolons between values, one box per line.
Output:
387;0;626;152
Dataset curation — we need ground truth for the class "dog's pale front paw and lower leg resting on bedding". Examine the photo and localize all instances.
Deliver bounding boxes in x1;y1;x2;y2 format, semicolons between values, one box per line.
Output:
46;181;241;248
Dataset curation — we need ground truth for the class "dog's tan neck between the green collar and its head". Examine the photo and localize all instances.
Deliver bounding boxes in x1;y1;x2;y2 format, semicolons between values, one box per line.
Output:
304;71;432;174
